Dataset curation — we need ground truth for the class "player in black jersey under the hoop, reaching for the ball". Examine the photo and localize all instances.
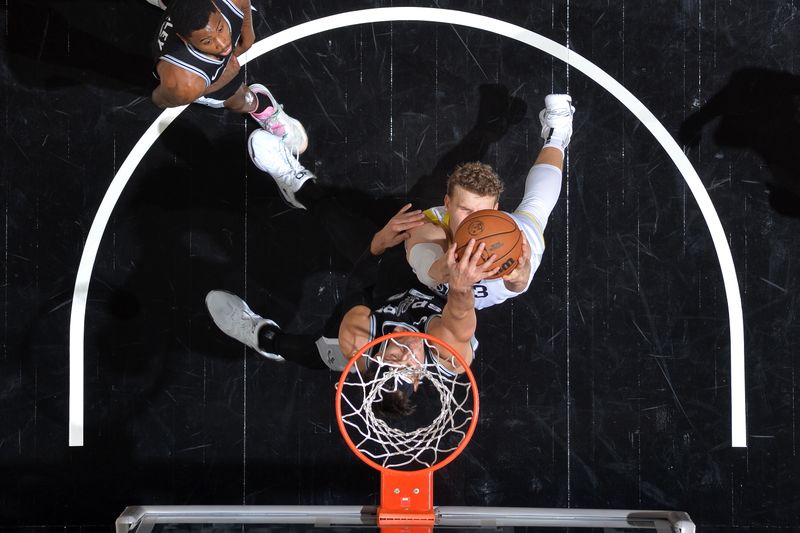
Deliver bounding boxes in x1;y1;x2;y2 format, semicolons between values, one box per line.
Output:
206;204;497;414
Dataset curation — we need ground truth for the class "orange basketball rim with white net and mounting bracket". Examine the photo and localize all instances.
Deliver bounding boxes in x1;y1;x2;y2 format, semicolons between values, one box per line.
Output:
336;331;478;531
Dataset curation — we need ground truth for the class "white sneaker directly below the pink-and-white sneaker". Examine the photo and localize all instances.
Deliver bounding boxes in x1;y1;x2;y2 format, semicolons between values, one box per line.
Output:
247;130;317;209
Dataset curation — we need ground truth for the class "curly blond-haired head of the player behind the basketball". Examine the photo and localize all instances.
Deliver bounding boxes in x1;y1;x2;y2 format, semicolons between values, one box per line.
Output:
444;162;503;231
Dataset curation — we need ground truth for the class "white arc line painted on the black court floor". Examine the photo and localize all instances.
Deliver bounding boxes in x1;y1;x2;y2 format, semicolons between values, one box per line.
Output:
69;7;747;447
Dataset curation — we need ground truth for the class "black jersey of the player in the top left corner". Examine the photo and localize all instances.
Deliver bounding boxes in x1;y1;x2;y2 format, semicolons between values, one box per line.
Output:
153;0;244;87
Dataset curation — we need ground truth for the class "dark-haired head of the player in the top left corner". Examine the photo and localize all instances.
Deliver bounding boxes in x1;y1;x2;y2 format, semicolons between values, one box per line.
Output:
169;0;233;57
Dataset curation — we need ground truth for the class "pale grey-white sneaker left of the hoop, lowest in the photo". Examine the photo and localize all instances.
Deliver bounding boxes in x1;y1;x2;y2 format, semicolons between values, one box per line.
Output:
206;291;284;361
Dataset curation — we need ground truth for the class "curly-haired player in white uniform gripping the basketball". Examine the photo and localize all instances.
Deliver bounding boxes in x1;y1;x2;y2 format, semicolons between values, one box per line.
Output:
406;94;575;309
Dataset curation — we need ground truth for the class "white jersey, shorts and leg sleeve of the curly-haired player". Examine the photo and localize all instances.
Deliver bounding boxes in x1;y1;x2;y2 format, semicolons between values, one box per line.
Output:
425;164;561;309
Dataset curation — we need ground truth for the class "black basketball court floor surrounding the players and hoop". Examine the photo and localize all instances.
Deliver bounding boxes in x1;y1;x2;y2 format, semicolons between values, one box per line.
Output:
0;0;800;531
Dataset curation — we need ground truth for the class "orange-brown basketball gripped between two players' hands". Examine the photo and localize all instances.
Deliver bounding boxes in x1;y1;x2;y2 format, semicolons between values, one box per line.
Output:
454;209;522;279
